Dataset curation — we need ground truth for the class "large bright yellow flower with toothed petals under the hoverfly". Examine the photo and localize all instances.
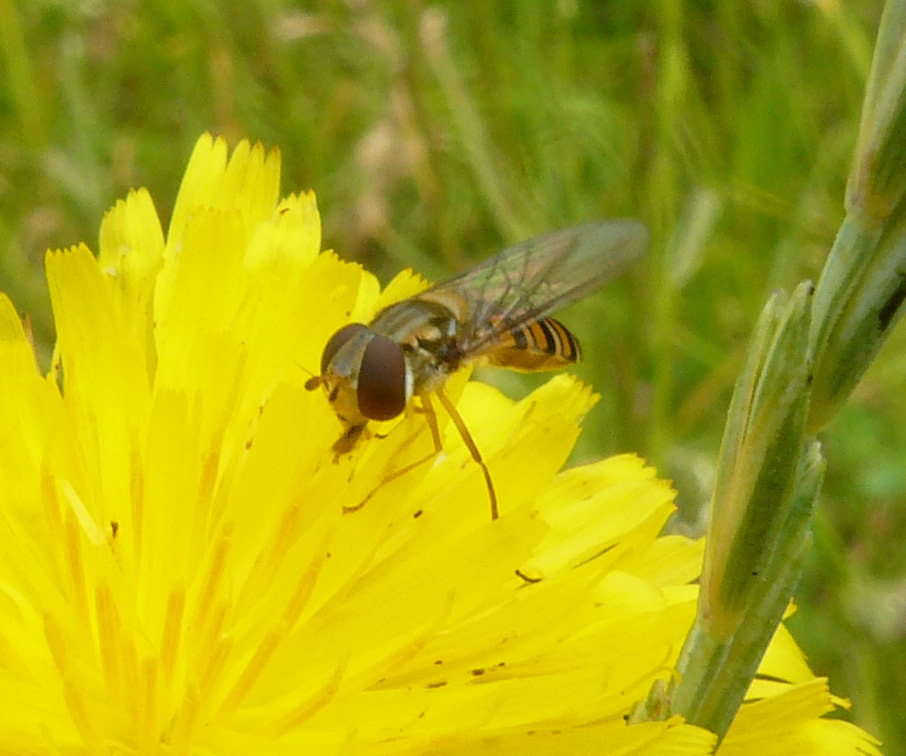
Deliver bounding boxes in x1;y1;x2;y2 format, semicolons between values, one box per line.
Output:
0;136;871;754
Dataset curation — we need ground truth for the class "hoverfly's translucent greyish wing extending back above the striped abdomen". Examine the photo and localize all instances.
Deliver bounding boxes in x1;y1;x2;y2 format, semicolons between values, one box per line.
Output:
413;219;648;356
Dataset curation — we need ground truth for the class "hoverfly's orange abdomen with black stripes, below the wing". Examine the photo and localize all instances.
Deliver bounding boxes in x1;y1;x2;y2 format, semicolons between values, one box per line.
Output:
483;318;582;371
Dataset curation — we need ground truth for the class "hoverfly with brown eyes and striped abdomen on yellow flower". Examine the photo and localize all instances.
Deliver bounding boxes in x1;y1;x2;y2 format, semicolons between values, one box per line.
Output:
305;219;648;519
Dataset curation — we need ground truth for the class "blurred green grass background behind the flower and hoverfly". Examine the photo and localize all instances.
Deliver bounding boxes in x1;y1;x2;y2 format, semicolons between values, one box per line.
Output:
0;0;906;754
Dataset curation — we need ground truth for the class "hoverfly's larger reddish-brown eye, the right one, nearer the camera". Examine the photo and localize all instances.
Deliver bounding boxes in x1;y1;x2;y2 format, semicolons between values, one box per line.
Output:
358;334;408;420
